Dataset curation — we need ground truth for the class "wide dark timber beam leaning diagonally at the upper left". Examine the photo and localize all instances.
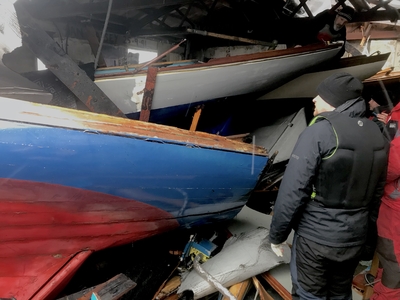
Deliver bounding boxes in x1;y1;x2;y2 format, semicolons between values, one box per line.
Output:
14;1;125;117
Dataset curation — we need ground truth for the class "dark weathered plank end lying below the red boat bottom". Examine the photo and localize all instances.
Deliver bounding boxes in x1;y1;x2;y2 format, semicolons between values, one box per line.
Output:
58;274;136;300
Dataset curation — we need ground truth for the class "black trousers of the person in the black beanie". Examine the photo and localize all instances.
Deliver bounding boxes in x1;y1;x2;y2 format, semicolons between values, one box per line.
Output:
290;234;363;300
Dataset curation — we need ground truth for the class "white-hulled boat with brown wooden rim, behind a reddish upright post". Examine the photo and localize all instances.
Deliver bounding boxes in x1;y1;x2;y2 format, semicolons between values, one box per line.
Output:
95;44;342;122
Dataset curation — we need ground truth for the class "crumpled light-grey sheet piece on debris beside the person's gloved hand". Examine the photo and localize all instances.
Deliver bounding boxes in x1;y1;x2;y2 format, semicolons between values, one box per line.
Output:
178;227;290;299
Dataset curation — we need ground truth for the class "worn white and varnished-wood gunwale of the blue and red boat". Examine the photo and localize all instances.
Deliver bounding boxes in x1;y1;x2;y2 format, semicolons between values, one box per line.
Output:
0;97;268;156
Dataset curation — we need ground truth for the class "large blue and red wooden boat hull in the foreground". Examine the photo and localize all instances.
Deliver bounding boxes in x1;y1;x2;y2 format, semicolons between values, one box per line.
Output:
0;98;268;300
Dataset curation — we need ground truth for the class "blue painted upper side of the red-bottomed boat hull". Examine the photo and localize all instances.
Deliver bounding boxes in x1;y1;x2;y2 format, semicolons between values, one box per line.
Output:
0;121;267;222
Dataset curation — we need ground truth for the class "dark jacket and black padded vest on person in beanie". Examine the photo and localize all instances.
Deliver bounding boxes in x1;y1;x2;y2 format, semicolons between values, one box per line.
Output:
270;98;388;247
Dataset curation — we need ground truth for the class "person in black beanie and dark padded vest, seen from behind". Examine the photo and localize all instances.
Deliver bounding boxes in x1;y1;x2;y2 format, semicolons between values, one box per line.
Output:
269;72;388;300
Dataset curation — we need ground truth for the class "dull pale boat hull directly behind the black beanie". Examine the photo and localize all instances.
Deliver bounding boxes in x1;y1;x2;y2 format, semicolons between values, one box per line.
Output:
258;53;390;100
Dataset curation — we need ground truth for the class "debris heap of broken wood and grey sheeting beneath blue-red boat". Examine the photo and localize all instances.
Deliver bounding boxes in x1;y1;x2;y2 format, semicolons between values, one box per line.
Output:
59;227;290;300
